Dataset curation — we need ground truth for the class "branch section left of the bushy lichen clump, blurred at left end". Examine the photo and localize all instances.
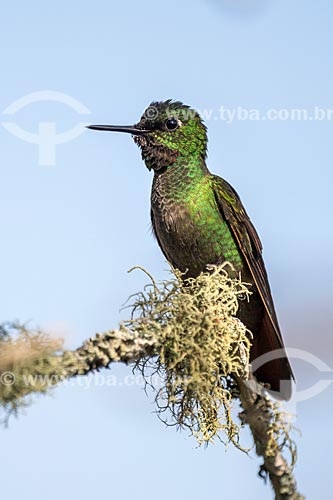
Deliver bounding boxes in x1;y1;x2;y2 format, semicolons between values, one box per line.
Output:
0;323;157;416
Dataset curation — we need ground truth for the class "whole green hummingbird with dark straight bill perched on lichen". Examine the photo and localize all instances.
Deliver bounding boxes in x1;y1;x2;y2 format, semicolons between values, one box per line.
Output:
88;99;294;400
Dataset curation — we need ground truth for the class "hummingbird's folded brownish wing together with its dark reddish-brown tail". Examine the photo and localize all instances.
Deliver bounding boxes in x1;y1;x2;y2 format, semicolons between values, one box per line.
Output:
211;175;294;399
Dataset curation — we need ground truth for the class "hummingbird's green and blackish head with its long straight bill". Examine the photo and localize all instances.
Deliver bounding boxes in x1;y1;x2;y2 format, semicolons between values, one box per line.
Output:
88;99;207;171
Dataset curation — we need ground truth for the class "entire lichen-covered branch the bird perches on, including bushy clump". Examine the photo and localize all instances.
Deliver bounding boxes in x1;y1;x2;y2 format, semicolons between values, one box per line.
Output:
0;264;303;500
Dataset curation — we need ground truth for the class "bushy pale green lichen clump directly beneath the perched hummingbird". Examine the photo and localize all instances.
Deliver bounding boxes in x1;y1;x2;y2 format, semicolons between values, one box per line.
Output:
126;264;251;446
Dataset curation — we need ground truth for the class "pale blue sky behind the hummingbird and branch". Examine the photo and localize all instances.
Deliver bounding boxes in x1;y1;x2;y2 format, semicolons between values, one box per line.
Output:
0;0;333;500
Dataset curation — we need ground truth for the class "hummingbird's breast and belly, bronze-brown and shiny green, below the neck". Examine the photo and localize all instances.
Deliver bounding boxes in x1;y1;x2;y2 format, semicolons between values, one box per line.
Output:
151;170;243;277
